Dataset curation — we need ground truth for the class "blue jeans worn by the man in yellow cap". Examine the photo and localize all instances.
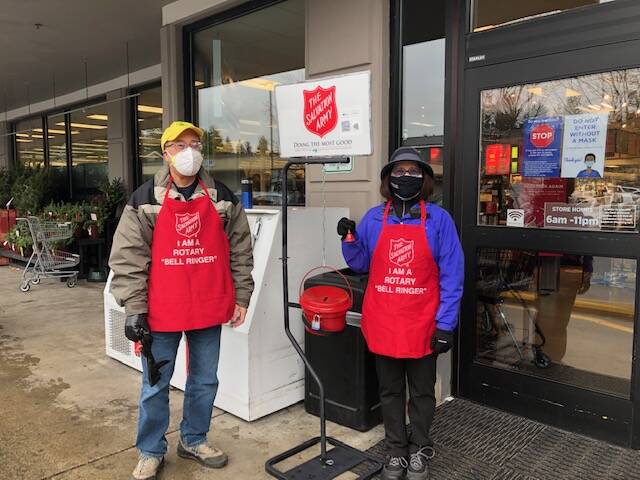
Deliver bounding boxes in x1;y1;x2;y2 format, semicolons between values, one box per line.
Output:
136;326;221;457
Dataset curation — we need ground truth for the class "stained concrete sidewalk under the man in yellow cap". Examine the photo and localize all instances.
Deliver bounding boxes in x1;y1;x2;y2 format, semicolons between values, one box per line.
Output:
0;267;383;480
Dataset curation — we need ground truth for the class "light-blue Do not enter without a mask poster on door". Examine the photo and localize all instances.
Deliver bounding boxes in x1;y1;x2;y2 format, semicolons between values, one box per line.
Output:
562;113;609;178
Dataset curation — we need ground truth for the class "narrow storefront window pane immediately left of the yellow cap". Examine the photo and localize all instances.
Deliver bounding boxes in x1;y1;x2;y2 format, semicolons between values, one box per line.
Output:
135;86;163;182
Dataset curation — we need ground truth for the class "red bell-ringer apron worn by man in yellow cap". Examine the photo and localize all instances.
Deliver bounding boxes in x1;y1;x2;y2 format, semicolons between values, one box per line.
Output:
148;179;235;332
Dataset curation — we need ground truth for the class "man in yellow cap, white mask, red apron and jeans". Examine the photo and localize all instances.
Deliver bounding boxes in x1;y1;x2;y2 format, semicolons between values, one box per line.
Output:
109;122;253;480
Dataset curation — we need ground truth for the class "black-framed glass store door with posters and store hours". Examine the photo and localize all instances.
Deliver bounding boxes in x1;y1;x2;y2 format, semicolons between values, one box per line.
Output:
457;37;640;446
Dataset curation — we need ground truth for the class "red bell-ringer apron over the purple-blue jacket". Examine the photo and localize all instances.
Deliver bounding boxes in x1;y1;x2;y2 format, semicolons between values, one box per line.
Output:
362;201;440;358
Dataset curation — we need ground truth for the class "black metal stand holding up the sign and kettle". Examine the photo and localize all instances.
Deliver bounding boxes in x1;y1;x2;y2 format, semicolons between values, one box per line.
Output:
265;158;382;480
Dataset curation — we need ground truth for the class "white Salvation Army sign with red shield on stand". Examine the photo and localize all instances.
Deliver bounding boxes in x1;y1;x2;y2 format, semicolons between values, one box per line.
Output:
276;71;372;158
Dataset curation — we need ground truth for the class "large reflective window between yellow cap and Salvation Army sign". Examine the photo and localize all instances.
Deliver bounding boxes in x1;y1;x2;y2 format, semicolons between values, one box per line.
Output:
191;0;305;205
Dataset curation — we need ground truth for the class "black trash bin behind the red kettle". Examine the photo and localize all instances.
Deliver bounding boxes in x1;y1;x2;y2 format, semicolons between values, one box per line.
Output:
304;269;382;432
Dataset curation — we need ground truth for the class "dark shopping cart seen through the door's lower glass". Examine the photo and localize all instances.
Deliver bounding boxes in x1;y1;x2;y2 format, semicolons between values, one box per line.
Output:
476;248;551;368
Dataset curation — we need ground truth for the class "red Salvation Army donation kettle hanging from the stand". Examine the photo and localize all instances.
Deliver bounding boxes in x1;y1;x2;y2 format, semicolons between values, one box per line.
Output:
299;266;353;336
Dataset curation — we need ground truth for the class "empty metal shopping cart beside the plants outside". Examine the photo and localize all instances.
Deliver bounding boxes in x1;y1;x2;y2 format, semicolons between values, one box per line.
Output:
17;217;80;292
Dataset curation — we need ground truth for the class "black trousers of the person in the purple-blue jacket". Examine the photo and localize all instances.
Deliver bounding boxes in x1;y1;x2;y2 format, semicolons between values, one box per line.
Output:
375;355;437;457
